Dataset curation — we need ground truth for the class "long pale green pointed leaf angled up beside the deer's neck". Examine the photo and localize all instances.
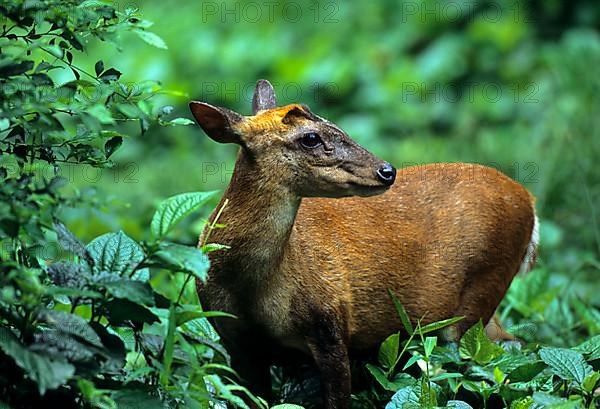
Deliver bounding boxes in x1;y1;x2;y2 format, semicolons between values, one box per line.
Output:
150;191;217;238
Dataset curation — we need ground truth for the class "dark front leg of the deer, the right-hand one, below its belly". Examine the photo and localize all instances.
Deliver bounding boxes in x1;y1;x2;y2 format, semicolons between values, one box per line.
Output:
307;321;351;409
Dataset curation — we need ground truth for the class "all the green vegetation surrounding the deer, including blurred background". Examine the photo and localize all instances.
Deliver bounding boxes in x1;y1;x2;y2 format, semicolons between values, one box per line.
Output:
0;0;600;409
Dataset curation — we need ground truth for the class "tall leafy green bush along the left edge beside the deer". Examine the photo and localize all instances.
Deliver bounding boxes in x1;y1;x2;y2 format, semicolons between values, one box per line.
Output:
0;0;261;408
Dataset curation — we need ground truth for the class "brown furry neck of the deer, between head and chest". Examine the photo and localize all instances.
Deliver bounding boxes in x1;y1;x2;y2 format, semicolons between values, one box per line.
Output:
209;151;300;286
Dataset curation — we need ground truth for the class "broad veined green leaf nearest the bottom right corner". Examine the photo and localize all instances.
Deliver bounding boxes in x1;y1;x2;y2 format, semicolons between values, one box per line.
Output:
540;348;594;386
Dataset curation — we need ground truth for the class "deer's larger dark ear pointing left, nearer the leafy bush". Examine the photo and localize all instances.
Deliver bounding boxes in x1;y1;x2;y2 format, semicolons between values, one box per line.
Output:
190;101;244;144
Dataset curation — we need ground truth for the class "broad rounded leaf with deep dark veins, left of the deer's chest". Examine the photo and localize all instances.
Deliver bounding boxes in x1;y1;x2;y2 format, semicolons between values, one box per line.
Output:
87;231;145;274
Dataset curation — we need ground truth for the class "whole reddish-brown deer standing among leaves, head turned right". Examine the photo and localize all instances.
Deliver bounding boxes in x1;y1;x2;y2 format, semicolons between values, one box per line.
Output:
190;80;538;409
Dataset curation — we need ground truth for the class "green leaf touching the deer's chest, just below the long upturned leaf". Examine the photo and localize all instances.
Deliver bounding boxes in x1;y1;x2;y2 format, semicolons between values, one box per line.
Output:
154;242;210;281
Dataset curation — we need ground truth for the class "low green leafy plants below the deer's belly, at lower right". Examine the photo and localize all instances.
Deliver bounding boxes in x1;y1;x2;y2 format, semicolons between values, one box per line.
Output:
360;299;600;409
